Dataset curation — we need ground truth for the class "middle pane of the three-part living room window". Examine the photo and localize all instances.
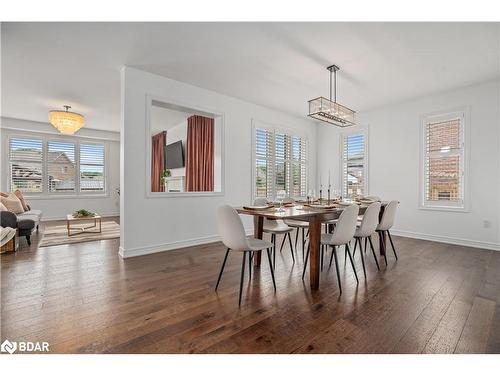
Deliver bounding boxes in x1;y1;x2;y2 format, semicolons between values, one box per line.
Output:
47;141;76;193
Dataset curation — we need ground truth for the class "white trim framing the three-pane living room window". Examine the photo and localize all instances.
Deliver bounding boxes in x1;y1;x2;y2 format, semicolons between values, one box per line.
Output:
4;131;110;200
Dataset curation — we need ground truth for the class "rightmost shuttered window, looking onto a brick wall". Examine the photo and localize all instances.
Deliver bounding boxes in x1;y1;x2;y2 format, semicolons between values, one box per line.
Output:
421;112;465;209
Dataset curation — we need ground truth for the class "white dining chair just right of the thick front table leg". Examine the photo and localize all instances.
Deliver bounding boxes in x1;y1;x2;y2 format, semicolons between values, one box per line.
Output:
302;204;359;294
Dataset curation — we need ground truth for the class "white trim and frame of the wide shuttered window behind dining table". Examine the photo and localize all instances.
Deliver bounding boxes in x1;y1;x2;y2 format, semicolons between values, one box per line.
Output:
250;119;310;202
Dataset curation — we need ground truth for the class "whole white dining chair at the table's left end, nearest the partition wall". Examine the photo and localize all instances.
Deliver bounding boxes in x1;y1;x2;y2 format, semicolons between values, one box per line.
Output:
215;205;276;306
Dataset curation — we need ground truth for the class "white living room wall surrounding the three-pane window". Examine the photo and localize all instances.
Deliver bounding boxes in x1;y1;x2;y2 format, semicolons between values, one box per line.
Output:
0;117;120;220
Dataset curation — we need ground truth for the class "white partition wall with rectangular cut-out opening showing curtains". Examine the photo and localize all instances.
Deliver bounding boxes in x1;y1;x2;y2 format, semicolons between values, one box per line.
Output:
120;68;316;257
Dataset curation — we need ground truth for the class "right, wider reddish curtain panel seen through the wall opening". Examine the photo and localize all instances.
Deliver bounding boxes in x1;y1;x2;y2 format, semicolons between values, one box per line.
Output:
186;116;214;191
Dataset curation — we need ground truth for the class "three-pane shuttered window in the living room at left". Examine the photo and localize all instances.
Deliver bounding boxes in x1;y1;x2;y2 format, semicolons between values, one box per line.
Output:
8;136;106;195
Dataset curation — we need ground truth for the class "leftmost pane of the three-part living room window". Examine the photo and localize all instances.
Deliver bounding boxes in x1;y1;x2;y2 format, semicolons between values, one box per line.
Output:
9;138;43;193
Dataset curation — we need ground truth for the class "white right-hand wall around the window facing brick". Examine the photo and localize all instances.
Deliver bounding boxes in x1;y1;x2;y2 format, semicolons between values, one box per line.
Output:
318;80;500;250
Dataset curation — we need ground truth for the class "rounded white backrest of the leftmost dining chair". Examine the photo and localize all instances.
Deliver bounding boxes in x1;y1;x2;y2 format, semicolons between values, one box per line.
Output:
217;205;248;250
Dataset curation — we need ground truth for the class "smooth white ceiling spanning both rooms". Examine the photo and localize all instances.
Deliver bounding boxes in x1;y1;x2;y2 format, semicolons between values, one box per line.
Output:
1;23;500;130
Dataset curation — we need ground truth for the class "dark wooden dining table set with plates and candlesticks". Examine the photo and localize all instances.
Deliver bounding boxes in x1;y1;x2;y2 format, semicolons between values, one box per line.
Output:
236;202;387;290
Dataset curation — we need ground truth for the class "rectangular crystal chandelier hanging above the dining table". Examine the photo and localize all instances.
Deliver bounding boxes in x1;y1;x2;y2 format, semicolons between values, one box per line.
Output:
308;65;356;127
